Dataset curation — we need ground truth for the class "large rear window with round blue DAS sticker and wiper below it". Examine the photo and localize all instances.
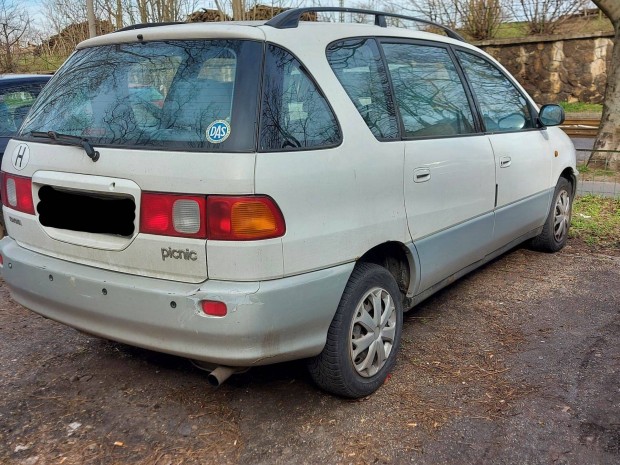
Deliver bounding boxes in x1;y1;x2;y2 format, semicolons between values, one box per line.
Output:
20;40;262;152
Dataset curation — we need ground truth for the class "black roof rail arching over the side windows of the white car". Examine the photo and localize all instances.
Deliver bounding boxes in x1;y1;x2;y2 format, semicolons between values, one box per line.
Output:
265;6;466;42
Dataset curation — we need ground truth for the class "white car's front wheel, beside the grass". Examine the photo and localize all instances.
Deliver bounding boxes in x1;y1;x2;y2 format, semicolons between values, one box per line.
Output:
531;178;573;252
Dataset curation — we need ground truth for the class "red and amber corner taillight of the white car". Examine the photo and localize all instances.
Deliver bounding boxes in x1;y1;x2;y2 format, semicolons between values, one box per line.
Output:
207;195;286;241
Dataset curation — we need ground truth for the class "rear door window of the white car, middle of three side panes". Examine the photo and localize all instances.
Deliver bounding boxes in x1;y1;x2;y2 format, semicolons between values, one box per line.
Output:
382;43;475;137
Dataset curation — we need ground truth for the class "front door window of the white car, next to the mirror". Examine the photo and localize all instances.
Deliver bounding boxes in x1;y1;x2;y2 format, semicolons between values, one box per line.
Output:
456;51;534;132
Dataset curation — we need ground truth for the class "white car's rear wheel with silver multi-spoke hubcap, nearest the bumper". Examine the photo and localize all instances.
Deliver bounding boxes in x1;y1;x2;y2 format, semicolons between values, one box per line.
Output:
308;263;403;398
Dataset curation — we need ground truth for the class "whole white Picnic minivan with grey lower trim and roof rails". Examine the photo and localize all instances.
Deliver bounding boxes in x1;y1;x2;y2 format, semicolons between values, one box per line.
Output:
0;8;577;398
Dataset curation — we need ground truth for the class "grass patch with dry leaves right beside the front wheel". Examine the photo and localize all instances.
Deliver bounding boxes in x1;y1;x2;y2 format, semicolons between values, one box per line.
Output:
570;195;620;248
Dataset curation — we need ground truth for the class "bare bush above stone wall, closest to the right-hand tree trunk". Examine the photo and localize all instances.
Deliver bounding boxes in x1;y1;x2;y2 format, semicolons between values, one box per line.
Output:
512;0;589;34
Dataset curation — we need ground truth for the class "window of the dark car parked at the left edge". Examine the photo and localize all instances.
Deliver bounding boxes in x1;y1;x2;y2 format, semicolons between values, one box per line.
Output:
0;83;45;137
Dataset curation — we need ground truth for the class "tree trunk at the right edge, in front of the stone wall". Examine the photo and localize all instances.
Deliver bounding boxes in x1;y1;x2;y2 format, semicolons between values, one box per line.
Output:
588;0;620;169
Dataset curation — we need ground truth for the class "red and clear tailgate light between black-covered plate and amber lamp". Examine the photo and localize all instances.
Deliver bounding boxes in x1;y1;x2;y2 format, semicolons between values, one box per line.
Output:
140;192;206;239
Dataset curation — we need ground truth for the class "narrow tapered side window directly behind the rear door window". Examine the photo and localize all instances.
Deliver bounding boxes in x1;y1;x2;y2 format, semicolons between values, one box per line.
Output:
327;39;398;139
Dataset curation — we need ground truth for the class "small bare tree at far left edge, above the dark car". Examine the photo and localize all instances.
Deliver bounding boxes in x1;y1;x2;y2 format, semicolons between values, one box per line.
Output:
0;0;30;73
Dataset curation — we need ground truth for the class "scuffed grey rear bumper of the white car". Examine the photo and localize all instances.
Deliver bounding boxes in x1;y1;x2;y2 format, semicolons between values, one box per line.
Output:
0;237;354;366
